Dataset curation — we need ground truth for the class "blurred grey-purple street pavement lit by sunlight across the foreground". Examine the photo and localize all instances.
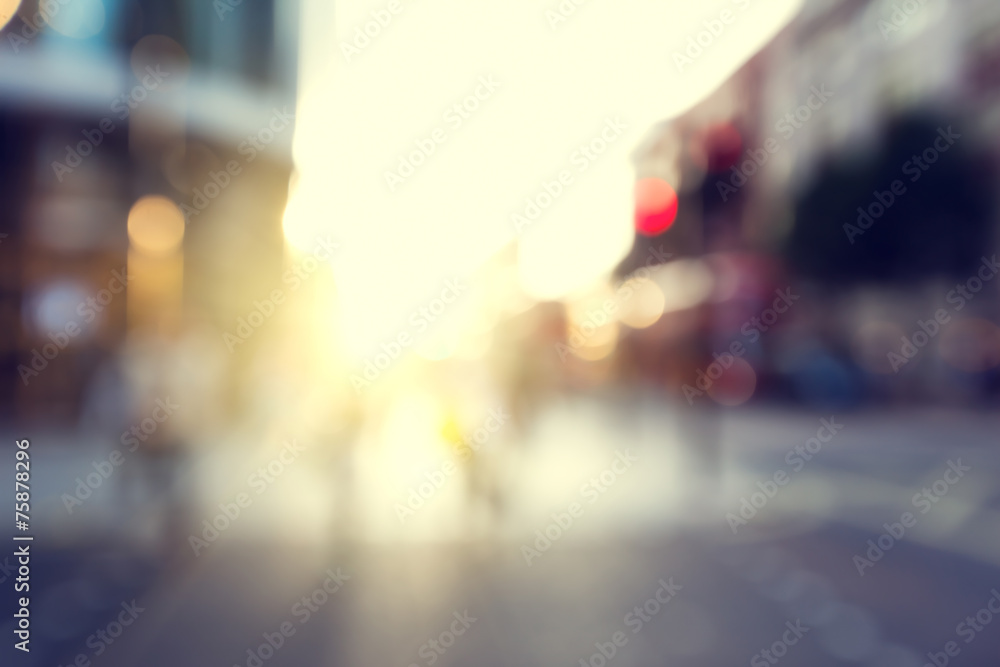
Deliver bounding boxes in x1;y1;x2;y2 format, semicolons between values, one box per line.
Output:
0;397;1000;667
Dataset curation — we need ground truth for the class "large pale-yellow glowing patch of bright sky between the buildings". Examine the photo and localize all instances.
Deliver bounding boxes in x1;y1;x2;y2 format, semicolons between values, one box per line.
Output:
284;0;802;357
